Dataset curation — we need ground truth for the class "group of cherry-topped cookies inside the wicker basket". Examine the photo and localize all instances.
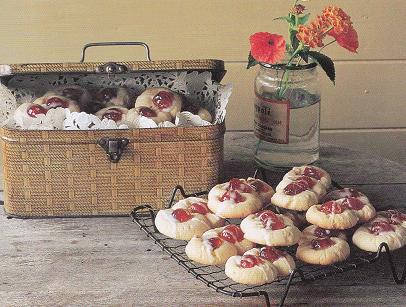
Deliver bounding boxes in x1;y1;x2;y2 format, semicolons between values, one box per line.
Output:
14;85;213;126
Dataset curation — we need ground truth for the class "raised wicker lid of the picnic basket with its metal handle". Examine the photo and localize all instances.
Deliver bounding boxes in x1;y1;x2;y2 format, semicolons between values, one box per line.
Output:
0;42;225;82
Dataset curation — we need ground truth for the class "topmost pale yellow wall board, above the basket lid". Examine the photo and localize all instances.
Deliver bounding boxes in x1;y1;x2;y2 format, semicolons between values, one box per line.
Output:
0;0;406;63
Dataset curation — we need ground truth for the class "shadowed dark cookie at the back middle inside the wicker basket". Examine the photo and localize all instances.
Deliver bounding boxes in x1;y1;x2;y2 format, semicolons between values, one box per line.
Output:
94;87;133;108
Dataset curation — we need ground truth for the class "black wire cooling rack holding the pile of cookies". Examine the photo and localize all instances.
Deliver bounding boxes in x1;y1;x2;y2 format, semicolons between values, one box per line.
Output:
131;169;406;306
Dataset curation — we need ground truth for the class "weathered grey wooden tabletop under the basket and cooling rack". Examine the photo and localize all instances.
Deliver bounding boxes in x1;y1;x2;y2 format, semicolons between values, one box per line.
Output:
0;132;406;306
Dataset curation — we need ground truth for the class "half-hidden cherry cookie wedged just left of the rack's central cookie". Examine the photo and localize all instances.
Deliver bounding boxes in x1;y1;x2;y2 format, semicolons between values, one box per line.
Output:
205;224;255;255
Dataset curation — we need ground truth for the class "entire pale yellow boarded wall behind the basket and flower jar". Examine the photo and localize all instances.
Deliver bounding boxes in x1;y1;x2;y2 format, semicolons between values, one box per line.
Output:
0;0;406;163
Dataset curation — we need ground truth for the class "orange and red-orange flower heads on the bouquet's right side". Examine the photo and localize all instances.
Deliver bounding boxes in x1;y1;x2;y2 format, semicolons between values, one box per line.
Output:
296;6;359;52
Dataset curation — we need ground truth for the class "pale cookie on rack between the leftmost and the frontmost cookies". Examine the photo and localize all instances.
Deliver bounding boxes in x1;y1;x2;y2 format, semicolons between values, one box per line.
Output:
185;231;238;265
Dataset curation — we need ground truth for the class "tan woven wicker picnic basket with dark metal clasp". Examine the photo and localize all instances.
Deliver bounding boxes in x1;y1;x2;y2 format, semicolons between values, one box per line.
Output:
0;41;225;218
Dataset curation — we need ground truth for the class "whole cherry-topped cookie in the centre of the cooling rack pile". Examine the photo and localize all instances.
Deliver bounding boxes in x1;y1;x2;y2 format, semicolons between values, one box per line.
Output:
240;210;301;246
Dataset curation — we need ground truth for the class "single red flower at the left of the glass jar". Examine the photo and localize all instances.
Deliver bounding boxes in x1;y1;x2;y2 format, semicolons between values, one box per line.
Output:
250;32;286;64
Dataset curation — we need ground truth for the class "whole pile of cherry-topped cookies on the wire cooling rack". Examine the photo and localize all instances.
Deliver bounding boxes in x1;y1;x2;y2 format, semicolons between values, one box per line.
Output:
155;166;406;285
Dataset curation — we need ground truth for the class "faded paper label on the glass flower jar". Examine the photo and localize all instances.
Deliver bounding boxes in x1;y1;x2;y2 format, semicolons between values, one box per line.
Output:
254;96;290;144
